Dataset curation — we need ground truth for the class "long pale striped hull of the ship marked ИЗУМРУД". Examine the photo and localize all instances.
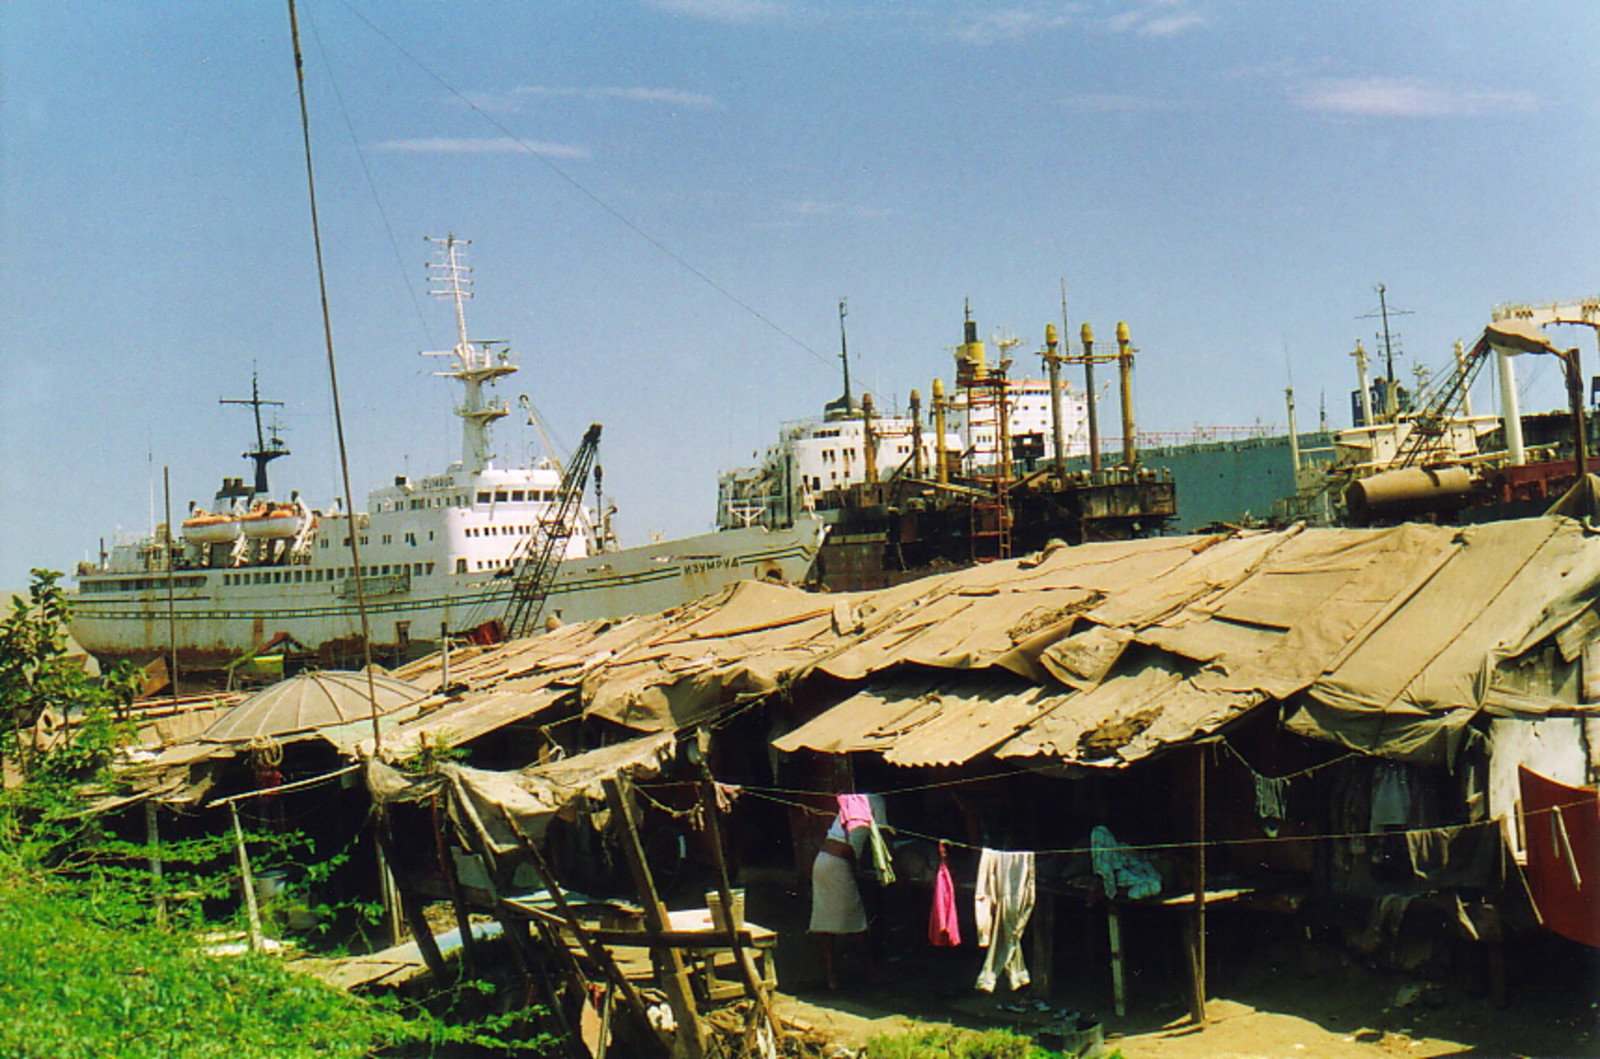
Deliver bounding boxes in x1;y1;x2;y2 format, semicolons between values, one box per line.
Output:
72;520;824;672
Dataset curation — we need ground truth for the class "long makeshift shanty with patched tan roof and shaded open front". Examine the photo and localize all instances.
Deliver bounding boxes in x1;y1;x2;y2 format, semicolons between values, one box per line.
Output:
365;517;1600;1023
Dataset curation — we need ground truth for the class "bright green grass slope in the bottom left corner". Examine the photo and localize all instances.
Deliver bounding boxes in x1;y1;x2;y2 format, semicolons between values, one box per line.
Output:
0;875;427;1059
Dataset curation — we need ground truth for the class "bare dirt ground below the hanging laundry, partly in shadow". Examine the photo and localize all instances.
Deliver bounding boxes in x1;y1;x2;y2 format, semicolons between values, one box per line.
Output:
726;888;1600;1059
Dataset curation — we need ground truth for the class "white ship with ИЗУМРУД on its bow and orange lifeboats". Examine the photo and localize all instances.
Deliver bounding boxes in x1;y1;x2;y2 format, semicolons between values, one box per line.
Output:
72;237;824;669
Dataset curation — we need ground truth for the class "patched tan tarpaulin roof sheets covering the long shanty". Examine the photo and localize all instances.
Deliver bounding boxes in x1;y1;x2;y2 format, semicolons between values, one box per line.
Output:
344;517;1600;765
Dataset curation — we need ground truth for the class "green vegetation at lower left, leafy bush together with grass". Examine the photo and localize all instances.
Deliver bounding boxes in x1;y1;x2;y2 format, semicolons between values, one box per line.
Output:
0;571;558;1059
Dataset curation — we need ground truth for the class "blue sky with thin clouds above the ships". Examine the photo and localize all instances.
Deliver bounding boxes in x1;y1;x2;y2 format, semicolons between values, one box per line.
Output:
0;0;1600;587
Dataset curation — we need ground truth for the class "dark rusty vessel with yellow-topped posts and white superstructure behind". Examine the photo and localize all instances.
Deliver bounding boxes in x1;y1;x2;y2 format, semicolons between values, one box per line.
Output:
717;310;1176;590
